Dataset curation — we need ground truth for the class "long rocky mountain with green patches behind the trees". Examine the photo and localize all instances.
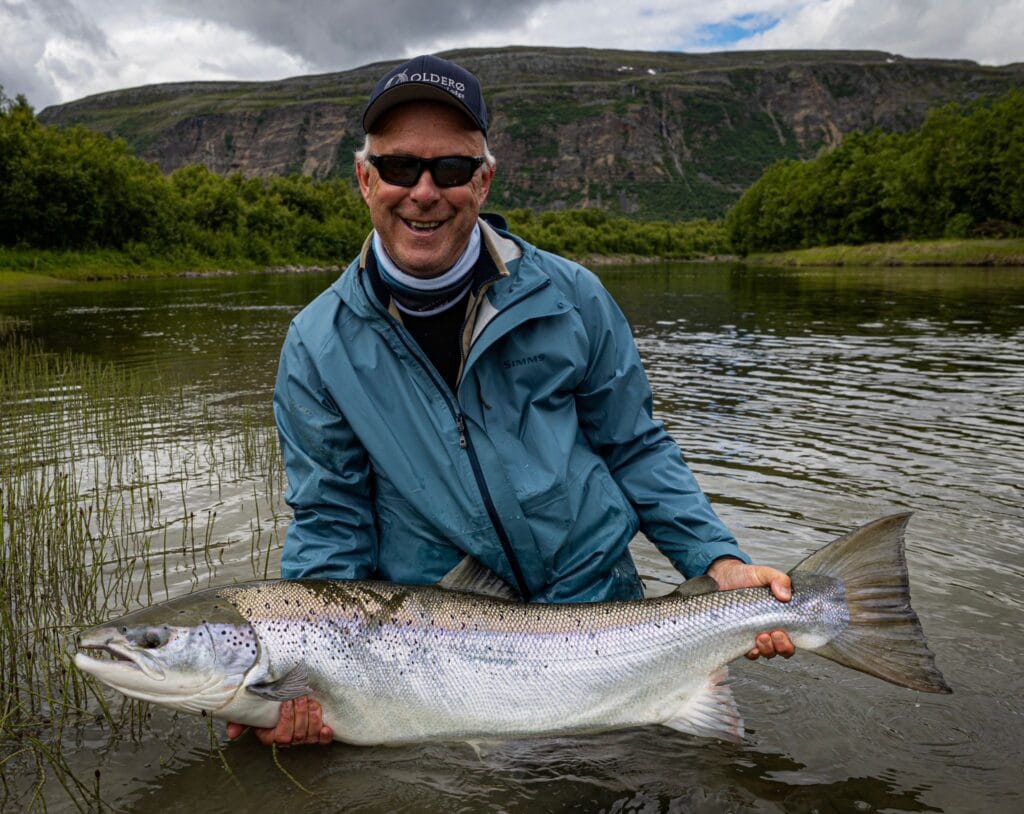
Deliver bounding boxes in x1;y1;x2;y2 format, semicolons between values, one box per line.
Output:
39;47;1024;218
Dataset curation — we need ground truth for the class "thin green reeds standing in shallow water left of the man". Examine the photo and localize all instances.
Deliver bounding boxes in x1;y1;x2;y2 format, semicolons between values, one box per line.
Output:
0;323;287;810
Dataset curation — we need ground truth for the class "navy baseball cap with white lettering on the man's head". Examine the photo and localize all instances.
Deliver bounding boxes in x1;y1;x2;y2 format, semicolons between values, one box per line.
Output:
362;54;487;135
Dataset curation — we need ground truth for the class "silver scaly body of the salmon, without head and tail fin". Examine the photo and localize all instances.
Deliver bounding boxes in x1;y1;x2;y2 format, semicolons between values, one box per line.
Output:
214;581;842;743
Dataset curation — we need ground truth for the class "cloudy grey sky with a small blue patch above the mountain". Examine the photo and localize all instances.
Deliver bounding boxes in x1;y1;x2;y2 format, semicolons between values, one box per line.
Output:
0;0;1024;111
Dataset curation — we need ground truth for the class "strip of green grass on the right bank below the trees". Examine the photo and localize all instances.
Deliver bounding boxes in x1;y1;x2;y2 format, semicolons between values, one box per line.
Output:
745;238;1024;266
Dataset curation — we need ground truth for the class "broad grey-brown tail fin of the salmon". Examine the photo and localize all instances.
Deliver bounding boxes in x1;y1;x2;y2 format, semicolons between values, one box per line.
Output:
790;512;952;693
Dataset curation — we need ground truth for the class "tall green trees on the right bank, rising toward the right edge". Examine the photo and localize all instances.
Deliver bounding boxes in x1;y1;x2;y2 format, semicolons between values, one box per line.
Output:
726;90;1024;254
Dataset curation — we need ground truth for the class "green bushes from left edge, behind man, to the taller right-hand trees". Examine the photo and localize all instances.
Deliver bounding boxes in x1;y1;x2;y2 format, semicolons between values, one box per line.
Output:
0;89;728;265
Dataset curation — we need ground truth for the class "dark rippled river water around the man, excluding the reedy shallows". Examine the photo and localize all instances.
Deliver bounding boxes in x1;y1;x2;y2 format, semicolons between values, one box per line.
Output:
0;265;1024;812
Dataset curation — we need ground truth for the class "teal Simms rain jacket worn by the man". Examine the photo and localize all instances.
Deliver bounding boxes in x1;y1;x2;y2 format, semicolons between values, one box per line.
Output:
274;220;750;602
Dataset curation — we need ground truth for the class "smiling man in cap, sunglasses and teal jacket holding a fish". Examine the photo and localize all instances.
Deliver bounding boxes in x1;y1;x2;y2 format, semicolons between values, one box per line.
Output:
229;56;794;743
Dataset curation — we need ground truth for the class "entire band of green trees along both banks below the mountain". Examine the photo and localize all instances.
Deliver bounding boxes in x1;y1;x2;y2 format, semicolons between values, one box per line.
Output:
0;87;1024;265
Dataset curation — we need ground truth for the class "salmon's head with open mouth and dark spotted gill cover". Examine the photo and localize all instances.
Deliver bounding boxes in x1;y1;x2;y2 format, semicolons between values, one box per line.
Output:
75;590;260;713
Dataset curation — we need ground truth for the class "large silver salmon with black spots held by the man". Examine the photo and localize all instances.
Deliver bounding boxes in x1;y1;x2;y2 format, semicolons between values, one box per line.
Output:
75;514;950;743
